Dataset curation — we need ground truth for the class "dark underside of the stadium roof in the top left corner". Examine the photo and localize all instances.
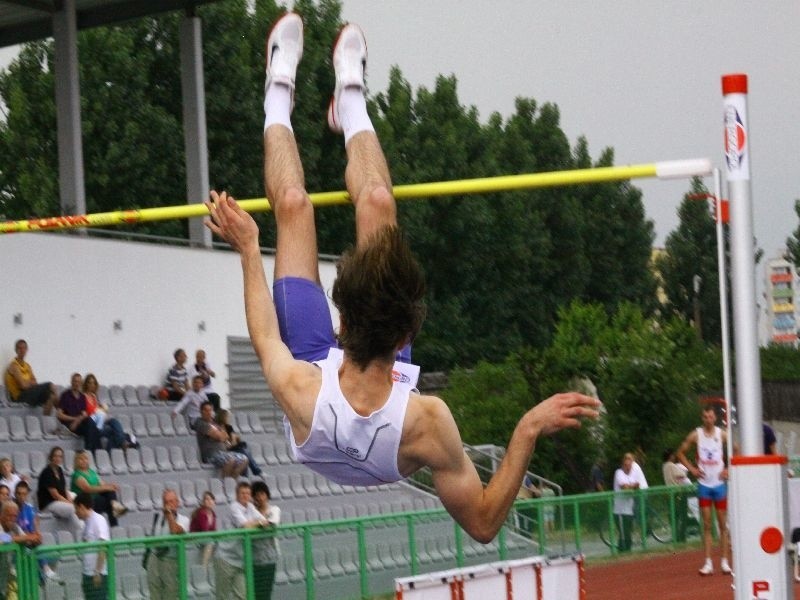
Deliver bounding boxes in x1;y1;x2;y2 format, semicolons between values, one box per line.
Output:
0;0;222;47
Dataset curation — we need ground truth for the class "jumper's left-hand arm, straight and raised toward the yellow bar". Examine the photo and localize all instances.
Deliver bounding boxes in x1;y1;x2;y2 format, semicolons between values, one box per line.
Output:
206;191;308;420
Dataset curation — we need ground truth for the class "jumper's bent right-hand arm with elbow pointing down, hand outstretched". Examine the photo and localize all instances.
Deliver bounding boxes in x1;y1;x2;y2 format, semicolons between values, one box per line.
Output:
423;393;600;543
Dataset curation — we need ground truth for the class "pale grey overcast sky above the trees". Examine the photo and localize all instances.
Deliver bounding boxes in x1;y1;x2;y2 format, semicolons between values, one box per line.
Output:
0;0;800;256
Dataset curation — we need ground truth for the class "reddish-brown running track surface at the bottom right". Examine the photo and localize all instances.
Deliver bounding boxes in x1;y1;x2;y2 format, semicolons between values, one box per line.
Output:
584;550;800;600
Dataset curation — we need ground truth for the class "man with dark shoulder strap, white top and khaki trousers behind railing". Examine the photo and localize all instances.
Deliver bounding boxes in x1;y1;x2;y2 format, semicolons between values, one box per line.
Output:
147;488;189;600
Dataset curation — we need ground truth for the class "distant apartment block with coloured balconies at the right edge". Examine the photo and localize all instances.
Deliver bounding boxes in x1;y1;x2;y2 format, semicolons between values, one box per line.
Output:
764;258;798;346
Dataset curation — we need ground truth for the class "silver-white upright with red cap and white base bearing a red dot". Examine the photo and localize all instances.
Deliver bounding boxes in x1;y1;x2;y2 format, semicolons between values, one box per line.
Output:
722;74;794;600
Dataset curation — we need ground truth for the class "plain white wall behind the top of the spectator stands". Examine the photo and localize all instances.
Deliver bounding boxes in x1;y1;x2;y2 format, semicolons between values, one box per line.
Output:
0;233;338;403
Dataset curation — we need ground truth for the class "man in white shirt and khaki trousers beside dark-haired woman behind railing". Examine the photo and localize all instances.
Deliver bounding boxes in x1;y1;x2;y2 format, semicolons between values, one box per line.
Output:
214;481;269;600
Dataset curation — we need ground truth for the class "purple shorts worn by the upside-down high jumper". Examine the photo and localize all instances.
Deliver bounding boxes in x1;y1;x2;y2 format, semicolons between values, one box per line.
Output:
272;277;411;363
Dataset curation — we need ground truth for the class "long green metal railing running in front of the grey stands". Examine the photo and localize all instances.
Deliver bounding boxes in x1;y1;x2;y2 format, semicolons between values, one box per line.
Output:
0;487;694;600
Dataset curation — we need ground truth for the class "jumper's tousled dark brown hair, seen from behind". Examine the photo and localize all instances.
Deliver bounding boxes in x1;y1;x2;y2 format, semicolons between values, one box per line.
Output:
331;226;425;369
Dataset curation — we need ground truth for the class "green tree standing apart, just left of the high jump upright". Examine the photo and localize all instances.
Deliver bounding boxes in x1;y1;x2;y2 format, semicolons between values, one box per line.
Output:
656;177;721;344
